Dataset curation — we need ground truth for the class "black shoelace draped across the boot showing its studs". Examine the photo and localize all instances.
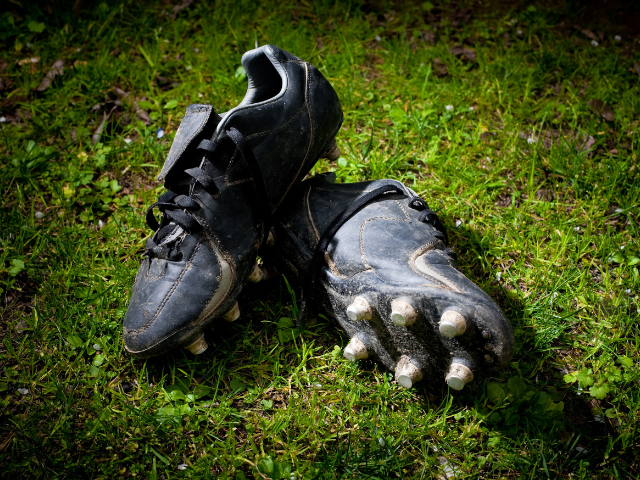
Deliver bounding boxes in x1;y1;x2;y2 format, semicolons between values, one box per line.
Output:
297;185;450;326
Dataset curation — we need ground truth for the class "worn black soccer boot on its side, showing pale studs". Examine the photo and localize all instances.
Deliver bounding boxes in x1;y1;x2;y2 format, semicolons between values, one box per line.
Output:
265;174;514;390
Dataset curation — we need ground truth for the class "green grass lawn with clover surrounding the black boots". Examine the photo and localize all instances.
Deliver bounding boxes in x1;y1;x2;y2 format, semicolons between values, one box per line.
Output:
0;1;640;479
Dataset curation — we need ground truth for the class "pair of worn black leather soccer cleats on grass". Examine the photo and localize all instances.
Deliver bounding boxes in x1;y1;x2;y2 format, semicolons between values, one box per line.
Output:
124;45;514;390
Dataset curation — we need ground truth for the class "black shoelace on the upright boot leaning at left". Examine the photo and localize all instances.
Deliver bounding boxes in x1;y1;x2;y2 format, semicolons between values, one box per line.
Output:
146;128;271;261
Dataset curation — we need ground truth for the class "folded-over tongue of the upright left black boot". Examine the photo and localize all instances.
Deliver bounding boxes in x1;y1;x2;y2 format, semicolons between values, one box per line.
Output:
158;104;222;180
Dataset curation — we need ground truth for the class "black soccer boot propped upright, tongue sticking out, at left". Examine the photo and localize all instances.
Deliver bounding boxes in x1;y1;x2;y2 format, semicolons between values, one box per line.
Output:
124;45;342;358
